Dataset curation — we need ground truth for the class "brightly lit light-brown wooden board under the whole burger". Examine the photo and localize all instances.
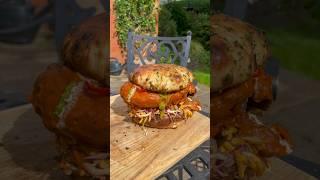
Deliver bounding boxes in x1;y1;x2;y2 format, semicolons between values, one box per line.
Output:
110;96;210;179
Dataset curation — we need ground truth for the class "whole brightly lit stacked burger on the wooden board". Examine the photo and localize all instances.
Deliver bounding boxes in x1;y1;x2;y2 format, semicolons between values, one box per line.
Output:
120;64;201;128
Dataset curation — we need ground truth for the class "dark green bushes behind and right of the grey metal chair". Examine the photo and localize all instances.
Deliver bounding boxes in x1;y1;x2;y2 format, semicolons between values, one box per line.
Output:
159;0;210;80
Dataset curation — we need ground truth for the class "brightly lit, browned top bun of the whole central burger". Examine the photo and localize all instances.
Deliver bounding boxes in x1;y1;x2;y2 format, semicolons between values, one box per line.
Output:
130;64;193;93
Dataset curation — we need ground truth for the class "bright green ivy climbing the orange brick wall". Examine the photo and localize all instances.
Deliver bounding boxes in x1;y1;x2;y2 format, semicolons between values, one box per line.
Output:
114;0;156;48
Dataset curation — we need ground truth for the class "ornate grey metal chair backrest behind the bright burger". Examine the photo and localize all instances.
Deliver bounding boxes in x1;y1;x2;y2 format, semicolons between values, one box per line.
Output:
127;31;191;74
